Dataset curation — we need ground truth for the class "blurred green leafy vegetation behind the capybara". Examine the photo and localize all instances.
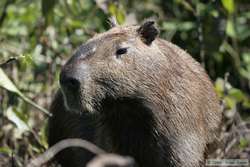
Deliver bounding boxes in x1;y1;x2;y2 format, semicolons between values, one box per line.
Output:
0;0;250;167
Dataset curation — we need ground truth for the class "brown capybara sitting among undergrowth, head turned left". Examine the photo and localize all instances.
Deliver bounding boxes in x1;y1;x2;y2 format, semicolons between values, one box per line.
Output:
49;21;221;167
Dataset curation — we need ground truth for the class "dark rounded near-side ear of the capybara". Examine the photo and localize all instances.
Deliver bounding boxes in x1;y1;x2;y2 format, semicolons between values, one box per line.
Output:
137;21;159;45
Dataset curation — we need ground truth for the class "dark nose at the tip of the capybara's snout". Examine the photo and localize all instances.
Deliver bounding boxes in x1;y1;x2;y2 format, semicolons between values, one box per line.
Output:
60;71;80;91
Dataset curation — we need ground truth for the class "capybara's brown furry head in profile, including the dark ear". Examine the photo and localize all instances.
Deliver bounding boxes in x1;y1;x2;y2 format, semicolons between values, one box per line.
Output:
60;21;167;112
